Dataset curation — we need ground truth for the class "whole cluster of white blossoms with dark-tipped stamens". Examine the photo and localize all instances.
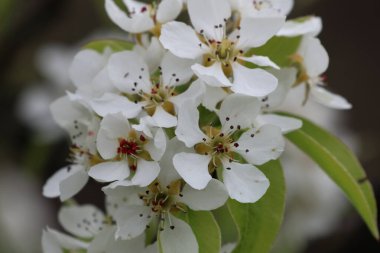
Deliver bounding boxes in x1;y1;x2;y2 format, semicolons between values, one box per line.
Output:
43;0;350;253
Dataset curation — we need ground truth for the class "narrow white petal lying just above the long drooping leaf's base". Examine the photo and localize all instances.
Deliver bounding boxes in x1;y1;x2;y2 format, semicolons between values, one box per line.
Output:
257;114;302;134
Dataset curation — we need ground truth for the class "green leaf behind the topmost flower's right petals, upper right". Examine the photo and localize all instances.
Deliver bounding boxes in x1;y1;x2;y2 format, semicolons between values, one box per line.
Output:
246;36;302;67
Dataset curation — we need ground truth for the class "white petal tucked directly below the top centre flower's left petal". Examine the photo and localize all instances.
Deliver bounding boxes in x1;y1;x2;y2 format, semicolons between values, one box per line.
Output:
161;52;194;87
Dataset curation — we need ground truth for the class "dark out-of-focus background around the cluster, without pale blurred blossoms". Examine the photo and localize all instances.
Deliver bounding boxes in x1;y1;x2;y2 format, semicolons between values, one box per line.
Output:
0;0;380;253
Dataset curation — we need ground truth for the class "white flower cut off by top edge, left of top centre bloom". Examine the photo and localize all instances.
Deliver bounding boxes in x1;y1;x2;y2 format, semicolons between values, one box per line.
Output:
105;0;183;35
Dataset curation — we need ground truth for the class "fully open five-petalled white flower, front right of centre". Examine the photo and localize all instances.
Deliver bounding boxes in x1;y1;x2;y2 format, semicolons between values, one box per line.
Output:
173;94;284;203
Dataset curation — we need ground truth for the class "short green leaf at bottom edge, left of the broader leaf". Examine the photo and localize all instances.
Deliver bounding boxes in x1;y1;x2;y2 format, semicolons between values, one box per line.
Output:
186;210;222;253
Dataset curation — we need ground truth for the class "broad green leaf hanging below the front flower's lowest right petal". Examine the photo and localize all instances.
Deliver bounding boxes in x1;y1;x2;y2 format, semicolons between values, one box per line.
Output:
228;161;285;253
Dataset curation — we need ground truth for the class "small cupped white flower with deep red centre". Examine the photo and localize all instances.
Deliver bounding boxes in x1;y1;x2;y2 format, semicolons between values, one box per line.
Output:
89;113;166;186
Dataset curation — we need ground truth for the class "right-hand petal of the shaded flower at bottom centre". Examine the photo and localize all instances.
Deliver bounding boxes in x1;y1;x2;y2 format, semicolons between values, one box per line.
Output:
178;179;228;211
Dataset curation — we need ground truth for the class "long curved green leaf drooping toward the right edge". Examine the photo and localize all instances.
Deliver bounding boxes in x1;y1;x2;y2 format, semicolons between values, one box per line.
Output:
281;113;379;239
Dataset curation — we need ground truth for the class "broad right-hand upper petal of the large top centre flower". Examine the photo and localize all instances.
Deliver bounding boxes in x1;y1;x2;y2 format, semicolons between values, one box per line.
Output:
236;16;285;49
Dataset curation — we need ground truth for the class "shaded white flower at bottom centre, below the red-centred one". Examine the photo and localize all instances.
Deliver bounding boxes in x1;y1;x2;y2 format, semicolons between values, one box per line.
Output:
104;138;228;253
